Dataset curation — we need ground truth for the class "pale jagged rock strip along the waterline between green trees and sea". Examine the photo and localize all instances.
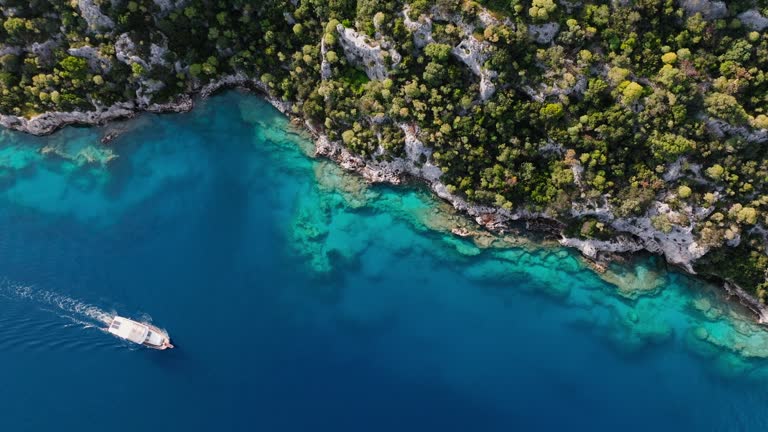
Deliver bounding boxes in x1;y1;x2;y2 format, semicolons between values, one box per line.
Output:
0;74;768;324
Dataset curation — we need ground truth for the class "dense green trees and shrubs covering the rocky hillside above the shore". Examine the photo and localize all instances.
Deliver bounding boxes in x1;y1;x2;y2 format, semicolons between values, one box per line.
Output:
0;0;768;299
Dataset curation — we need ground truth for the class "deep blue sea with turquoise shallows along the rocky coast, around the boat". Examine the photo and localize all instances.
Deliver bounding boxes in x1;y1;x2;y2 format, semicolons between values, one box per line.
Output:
0;92;768;432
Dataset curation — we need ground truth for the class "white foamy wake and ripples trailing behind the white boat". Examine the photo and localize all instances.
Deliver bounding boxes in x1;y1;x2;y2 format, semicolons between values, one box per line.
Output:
0;279;127;351
